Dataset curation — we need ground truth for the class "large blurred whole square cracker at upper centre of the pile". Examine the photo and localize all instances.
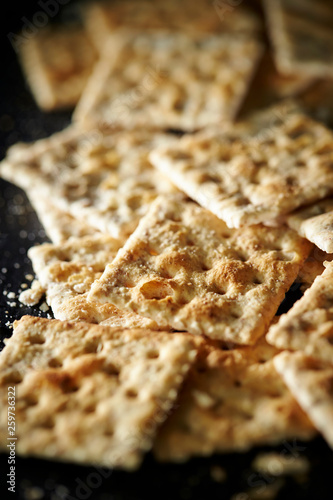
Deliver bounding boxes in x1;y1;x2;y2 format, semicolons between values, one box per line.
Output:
74;30;262;130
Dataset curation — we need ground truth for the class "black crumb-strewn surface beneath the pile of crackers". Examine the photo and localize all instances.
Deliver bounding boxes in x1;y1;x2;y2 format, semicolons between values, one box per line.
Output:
0;2;333;500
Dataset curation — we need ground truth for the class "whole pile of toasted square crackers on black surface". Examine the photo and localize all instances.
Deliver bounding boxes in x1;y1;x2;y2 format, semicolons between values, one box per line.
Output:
0;0;333;469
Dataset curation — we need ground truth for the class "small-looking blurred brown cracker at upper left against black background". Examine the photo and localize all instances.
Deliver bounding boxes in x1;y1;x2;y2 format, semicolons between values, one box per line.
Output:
18;26;97;111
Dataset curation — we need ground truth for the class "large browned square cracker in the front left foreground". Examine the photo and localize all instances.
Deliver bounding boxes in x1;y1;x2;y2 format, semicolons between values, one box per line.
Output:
0;316;195;469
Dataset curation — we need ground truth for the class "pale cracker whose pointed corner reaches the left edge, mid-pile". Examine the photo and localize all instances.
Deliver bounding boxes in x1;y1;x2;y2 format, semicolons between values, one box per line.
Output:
0;127;177;238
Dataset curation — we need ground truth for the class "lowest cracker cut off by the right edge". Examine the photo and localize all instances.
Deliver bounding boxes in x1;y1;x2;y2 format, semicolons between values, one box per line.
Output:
274;352;333;448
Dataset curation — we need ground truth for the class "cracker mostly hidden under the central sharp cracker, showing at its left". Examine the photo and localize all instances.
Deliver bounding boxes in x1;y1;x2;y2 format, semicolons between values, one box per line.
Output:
29;234;158;330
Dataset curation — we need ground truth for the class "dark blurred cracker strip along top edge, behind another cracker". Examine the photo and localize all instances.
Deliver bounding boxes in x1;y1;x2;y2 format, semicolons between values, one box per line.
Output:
84;0;261;51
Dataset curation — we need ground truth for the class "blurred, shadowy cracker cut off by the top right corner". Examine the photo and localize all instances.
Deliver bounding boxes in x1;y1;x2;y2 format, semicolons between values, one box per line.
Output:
264;0;333;77
